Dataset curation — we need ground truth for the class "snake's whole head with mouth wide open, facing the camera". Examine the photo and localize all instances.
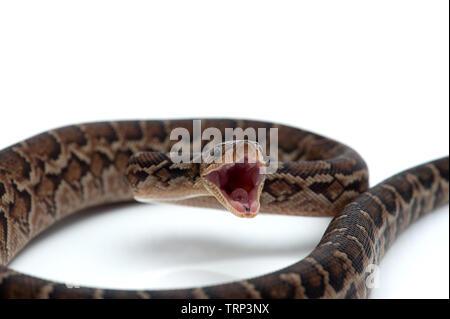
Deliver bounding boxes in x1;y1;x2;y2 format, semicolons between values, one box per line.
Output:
200;141;267;217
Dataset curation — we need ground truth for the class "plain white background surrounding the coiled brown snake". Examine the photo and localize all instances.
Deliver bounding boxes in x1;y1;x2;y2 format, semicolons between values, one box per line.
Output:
0;0;449;298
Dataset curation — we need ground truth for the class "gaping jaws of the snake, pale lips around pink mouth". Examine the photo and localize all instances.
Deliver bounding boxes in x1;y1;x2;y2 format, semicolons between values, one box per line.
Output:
202;142;266;217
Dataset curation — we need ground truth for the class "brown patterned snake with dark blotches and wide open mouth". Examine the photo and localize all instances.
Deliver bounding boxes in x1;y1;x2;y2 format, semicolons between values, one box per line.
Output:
0;119;449;299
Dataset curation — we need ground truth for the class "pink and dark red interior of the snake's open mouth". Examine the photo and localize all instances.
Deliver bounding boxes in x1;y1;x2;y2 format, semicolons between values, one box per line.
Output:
205;162;264;214
